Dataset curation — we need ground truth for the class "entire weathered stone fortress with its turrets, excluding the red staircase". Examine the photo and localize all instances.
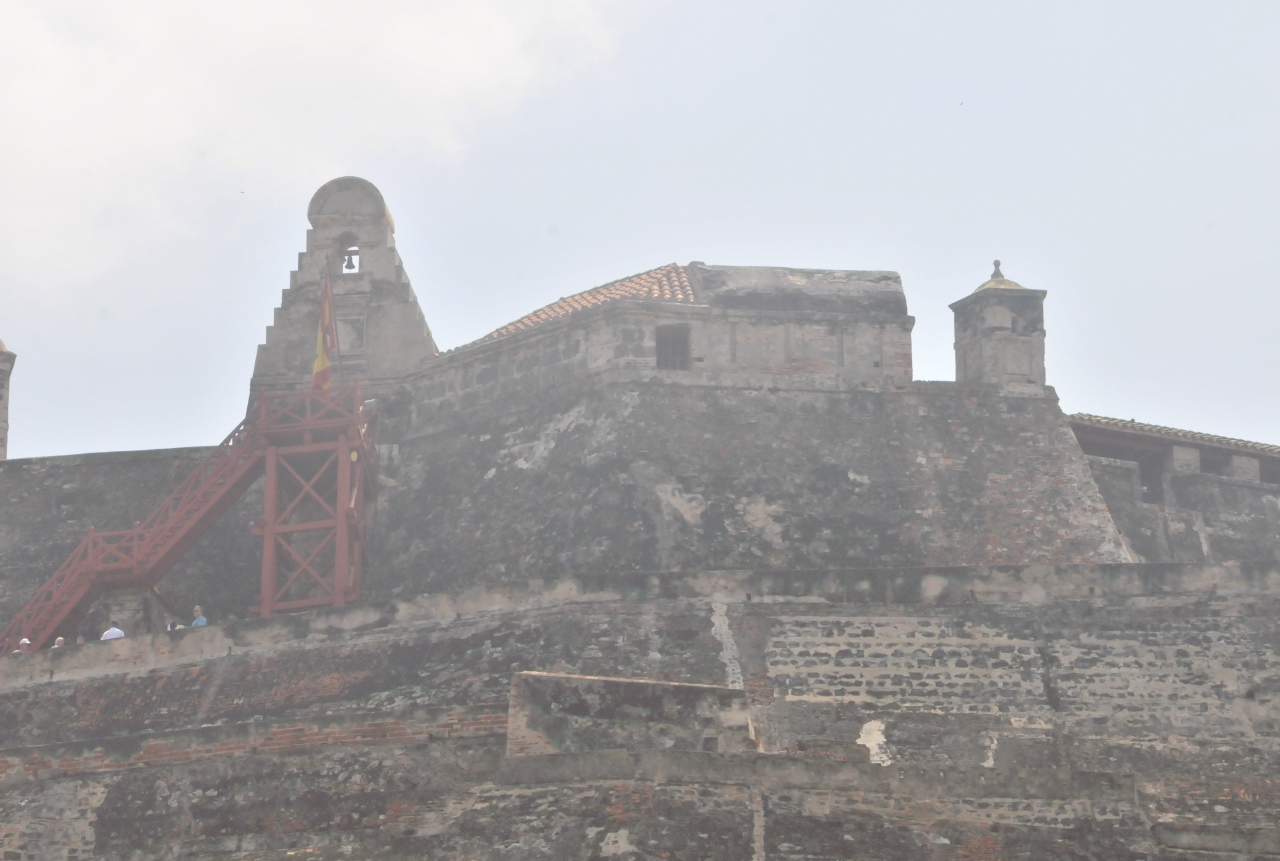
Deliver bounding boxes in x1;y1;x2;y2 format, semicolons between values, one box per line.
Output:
0;178;1280;861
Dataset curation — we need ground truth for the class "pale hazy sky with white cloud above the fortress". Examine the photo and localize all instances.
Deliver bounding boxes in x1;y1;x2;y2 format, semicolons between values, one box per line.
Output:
0;0;1280;457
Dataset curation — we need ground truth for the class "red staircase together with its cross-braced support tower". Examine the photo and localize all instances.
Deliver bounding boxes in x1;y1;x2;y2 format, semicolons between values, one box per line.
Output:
0;385;378;654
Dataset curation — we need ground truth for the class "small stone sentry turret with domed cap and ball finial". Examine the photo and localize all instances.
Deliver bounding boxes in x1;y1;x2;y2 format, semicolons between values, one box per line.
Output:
951;260;1048;395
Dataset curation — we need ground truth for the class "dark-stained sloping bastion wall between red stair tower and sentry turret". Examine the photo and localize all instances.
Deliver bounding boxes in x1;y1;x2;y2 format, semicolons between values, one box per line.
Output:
369;379;1128;600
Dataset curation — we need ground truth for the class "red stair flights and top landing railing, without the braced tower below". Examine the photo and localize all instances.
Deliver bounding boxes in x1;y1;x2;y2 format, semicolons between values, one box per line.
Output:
0;386;376;654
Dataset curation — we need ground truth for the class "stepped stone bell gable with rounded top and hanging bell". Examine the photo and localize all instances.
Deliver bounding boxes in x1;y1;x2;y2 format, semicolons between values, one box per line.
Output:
251;177;439;398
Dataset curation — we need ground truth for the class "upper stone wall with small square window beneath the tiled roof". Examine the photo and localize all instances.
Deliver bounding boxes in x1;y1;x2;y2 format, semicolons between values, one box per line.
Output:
404;302;913;441
